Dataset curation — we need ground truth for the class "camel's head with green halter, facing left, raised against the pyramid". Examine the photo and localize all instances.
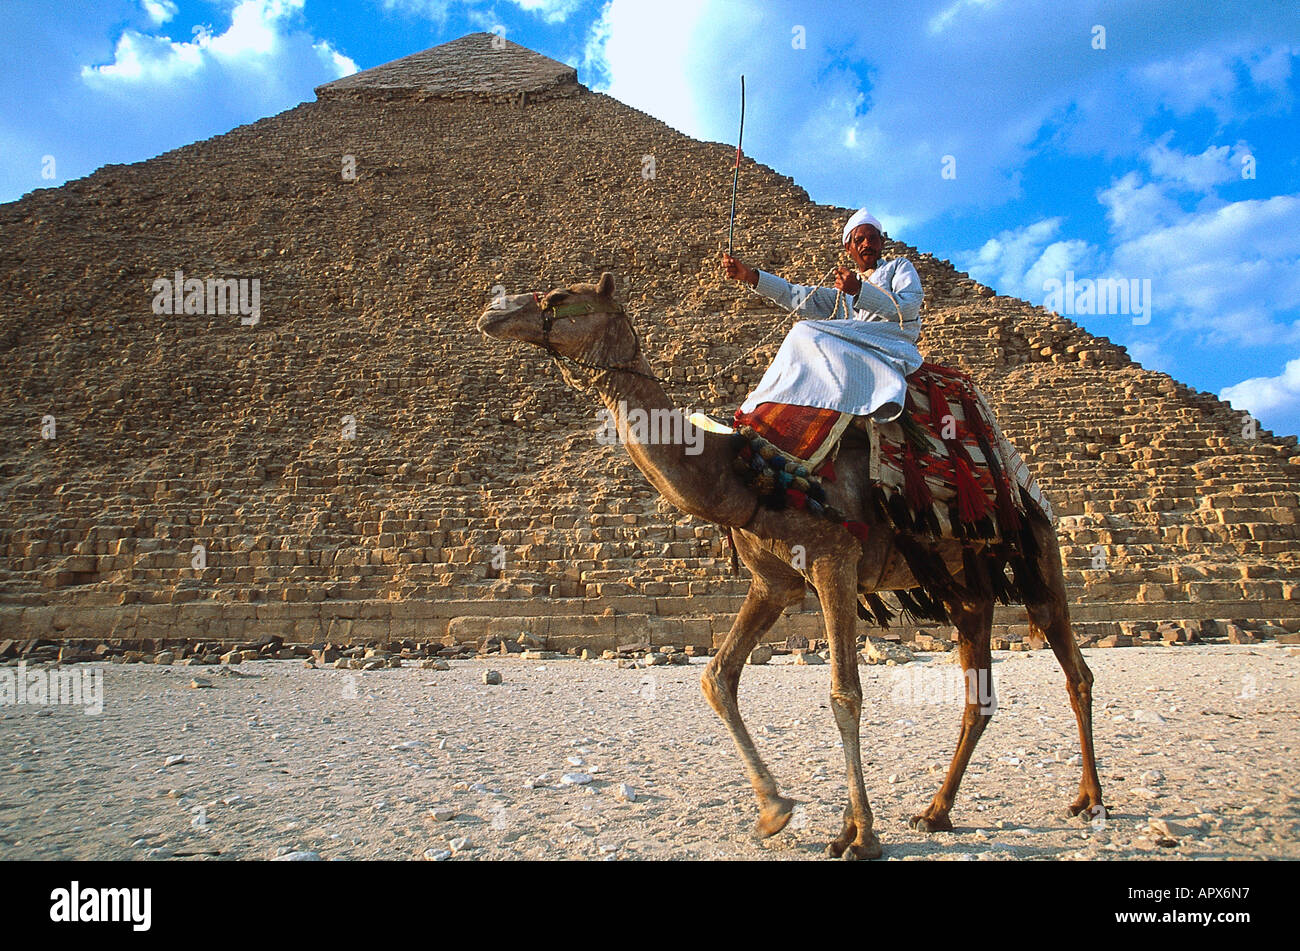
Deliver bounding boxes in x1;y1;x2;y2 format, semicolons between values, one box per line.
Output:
478;272;640;366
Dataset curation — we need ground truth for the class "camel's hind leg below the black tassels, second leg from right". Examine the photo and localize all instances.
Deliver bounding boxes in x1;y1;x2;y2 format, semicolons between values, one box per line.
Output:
910;600;997;833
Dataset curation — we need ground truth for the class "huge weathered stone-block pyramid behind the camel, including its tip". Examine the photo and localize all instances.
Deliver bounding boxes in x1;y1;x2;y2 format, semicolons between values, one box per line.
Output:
0;34;1300;644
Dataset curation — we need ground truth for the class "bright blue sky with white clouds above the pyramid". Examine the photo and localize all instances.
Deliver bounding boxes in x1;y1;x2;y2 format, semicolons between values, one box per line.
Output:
0;0;1300;434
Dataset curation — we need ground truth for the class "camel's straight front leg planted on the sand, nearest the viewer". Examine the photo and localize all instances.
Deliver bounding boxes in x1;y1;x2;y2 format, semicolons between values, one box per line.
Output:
813;559;881;859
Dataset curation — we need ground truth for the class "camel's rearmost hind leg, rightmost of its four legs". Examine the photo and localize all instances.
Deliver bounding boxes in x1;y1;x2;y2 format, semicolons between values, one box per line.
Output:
1024;513;1105;817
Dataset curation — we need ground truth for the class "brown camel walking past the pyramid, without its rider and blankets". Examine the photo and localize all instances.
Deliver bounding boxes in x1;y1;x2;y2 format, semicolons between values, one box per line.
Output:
478;273;1102;859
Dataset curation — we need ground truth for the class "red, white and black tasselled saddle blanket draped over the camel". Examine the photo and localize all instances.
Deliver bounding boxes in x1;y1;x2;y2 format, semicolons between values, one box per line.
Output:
731;362;1056;628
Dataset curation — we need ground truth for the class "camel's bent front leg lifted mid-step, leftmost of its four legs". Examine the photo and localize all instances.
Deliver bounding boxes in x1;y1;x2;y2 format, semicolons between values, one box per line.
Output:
699;533;805;835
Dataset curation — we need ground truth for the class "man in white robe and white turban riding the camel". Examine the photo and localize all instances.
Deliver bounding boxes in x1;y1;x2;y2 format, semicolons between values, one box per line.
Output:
723;208;922;422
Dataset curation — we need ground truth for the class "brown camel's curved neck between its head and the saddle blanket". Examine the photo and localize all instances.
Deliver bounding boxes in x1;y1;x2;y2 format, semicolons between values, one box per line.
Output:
595;356;758;527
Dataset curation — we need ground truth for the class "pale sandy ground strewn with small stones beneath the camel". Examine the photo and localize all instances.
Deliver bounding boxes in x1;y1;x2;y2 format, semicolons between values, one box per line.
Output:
0;646;1300;861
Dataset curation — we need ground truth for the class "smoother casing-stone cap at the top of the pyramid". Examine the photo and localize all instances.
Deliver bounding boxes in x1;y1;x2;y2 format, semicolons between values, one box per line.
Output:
316;32;584;100
